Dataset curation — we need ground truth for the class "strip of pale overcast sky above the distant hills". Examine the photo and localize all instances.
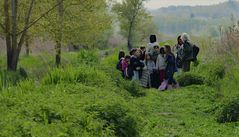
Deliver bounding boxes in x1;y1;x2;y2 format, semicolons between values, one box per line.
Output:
117;0;239;9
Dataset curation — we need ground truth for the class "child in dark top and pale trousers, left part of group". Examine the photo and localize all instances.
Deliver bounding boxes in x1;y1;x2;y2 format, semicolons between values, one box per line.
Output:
130;49;144;80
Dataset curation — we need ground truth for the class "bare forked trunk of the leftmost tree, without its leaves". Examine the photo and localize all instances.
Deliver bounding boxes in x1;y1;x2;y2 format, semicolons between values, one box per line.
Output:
3;0;35;71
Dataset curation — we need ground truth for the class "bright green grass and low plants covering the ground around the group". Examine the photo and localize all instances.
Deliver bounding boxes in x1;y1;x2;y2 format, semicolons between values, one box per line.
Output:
0;51;239;137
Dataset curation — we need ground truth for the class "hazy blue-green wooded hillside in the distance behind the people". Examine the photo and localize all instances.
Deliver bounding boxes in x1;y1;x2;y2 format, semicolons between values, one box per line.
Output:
151;1;239;36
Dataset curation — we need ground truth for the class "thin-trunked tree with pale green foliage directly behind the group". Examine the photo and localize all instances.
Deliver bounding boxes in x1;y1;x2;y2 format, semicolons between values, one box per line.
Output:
113;0;157;50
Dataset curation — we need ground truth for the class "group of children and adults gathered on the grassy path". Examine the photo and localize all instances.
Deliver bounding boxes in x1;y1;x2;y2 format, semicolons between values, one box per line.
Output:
117;33;199;90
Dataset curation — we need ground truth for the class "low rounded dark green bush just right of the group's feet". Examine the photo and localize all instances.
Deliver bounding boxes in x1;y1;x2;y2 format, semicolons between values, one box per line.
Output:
177;73;204;87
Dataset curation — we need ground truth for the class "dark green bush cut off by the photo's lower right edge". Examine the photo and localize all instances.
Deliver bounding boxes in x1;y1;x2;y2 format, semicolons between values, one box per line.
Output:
217;97;239;123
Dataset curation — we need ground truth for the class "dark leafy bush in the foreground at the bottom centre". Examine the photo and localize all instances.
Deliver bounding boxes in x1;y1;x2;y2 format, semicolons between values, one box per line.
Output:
86;103;138;137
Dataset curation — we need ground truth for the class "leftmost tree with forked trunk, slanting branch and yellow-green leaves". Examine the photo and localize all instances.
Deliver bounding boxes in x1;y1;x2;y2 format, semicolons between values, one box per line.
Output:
0;0;64;71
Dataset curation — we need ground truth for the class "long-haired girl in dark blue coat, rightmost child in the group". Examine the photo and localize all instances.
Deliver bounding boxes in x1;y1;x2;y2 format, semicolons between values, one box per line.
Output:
165;45;177;90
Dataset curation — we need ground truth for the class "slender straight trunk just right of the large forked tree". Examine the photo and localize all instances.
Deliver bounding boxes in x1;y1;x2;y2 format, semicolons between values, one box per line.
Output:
56;0;64;67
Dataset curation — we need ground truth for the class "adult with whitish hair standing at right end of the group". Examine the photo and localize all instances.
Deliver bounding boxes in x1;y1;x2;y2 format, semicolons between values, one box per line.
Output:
180;33;193;72
